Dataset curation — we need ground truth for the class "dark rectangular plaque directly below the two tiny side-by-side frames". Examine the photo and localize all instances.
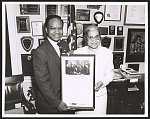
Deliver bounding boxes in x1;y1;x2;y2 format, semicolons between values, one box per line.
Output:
114;37;124;51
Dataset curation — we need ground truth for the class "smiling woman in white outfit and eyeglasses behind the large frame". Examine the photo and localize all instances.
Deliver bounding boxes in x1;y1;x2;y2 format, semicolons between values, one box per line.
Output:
74;25;114;115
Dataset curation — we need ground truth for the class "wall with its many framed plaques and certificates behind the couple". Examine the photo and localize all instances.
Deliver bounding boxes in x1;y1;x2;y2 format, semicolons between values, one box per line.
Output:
6;2;146;74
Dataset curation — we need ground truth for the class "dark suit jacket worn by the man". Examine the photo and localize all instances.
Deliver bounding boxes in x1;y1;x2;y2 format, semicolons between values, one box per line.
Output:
32;40;61;113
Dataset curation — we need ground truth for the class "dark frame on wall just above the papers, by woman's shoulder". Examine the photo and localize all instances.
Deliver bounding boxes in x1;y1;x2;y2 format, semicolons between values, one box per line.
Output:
113;52;124;69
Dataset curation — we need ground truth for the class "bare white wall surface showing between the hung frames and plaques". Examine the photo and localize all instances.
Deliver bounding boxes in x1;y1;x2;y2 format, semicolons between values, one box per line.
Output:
6;3;147;75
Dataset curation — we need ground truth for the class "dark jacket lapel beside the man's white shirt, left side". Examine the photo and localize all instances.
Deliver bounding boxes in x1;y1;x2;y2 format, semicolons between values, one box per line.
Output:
46;39;60;67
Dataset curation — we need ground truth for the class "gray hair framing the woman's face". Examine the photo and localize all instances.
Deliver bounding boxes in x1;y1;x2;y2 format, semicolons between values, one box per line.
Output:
84;24;101;46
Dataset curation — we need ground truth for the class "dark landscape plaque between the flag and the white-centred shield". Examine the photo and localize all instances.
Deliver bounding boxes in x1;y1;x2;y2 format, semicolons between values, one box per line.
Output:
76;9;90;21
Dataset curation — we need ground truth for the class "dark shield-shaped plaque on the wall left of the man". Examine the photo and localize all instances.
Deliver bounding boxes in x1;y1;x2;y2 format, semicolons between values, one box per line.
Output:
21;36;33;52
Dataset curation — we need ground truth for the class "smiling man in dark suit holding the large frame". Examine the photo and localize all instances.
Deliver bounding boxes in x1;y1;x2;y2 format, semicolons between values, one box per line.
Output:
32;15;69;114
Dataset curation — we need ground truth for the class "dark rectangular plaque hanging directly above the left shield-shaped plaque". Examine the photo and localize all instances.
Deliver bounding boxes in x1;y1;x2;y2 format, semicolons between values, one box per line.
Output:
16;16;30;33
